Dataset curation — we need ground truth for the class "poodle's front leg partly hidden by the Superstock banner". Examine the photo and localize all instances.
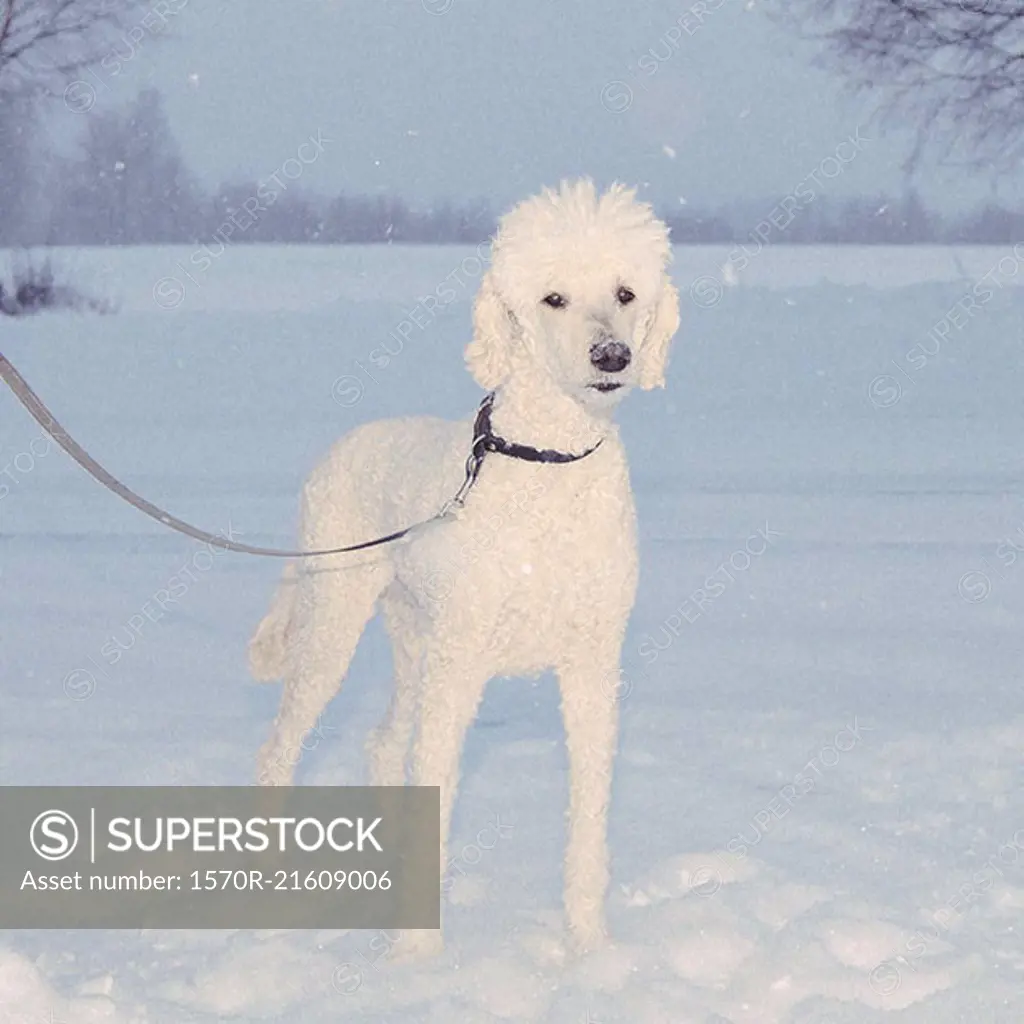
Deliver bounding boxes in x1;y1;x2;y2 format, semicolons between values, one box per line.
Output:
393;646;488;961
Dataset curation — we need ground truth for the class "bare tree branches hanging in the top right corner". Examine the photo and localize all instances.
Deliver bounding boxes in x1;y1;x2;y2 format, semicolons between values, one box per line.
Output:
784;0;1024;170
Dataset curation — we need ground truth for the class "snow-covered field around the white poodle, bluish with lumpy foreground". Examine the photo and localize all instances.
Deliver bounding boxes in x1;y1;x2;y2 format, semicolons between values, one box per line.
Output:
0;241;1024;1024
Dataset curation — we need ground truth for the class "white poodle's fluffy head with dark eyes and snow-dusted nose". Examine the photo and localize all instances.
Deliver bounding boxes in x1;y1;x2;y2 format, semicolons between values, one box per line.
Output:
466;180;679;408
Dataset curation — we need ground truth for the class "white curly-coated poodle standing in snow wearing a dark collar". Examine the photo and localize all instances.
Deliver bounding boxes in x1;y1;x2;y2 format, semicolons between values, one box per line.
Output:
250;180;679;951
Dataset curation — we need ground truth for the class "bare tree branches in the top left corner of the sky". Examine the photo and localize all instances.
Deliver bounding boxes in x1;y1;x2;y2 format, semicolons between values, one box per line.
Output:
0;0;148;95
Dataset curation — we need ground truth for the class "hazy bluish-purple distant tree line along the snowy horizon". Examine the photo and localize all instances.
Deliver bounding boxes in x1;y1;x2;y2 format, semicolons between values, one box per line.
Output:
6;89;1024;247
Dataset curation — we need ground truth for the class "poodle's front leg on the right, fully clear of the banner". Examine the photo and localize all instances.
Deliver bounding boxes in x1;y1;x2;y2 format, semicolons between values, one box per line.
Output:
558;649;620;951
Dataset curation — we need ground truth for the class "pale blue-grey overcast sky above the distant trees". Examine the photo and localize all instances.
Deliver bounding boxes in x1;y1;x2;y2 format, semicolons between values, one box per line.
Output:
44;0;1011;212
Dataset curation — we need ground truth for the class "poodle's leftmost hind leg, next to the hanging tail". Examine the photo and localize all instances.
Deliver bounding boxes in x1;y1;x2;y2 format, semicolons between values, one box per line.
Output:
256;561;391;785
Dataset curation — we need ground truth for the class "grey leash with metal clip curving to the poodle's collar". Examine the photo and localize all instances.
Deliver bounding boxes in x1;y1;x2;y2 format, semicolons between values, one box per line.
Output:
0;352;495;558
